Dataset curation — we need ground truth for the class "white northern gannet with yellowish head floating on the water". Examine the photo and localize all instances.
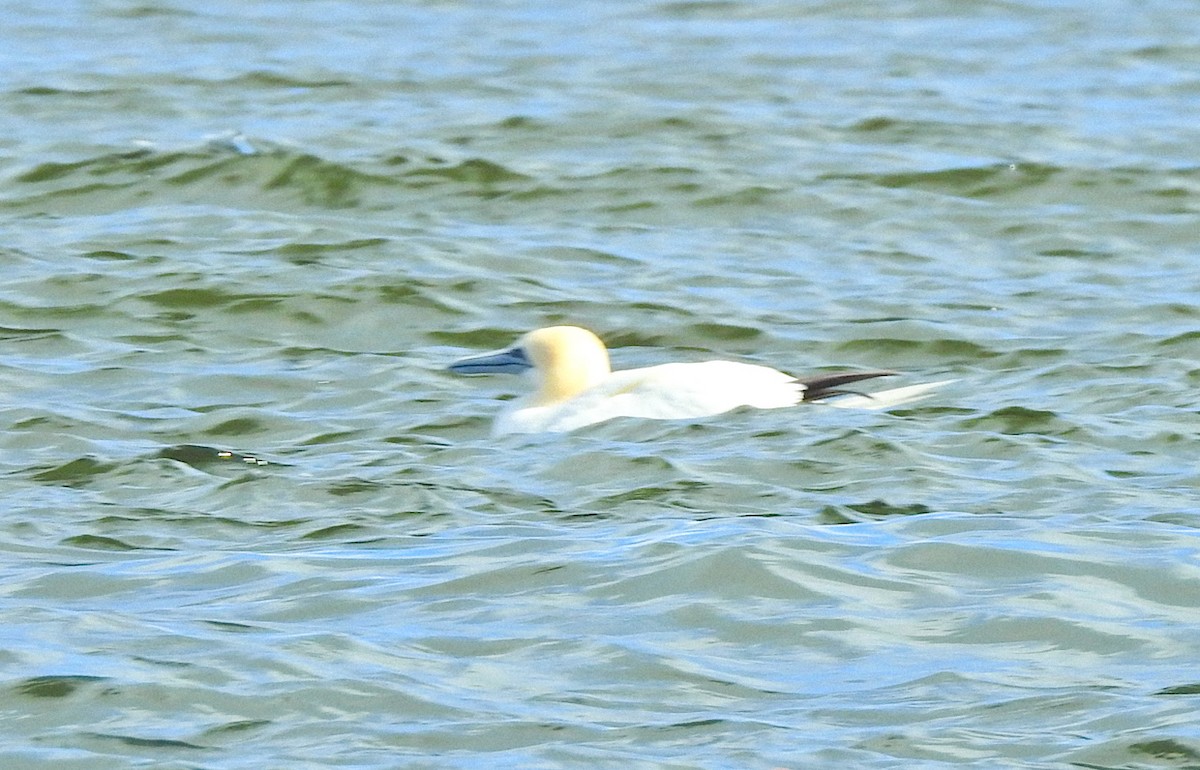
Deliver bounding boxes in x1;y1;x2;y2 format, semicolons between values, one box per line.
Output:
450;326;944;435
